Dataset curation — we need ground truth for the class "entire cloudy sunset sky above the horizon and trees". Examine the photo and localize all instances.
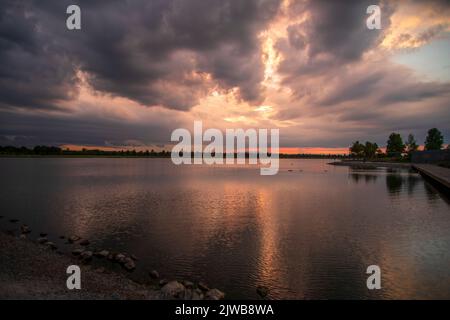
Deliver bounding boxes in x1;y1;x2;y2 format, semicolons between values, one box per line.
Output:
0;0;450;153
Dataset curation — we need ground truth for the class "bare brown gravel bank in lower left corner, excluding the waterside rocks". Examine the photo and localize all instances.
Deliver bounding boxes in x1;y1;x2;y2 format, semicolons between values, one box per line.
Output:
0;232;161;300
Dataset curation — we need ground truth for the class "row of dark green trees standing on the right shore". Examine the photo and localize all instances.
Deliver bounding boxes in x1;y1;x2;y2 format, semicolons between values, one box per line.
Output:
349;128;449;159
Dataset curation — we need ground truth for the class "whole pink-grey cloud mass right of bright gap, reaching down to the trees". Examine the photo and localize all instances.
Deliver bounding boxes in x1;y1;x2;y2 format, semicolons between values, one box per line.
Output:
268;1;450;146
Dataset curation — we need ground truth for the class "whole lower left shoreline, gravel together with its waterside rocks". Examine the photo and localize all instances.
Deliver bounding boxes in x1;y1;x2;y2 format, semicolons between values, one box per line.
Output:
0;216;225;300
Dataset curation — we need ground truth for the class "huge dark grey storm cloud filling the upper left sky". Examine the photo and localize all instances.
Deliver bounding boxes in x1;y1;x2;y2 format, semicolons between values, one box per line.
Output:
0;0;280;110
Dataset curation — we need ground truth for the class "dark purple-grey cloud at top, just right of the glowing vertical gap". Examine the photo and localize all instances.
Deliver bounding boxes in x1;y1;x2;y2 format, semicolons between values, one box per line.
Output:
277;0;393;75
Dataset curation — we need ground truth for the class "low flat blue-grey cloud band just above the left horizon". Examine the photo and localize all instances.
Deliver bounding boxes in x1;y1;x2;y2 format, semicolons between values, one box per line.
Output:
0;110;176;147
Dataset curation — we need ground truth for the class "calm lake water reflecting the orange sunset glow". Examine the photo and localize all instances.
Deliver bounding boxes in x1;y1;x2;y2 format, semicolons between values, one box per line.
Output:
0;158;450;299
